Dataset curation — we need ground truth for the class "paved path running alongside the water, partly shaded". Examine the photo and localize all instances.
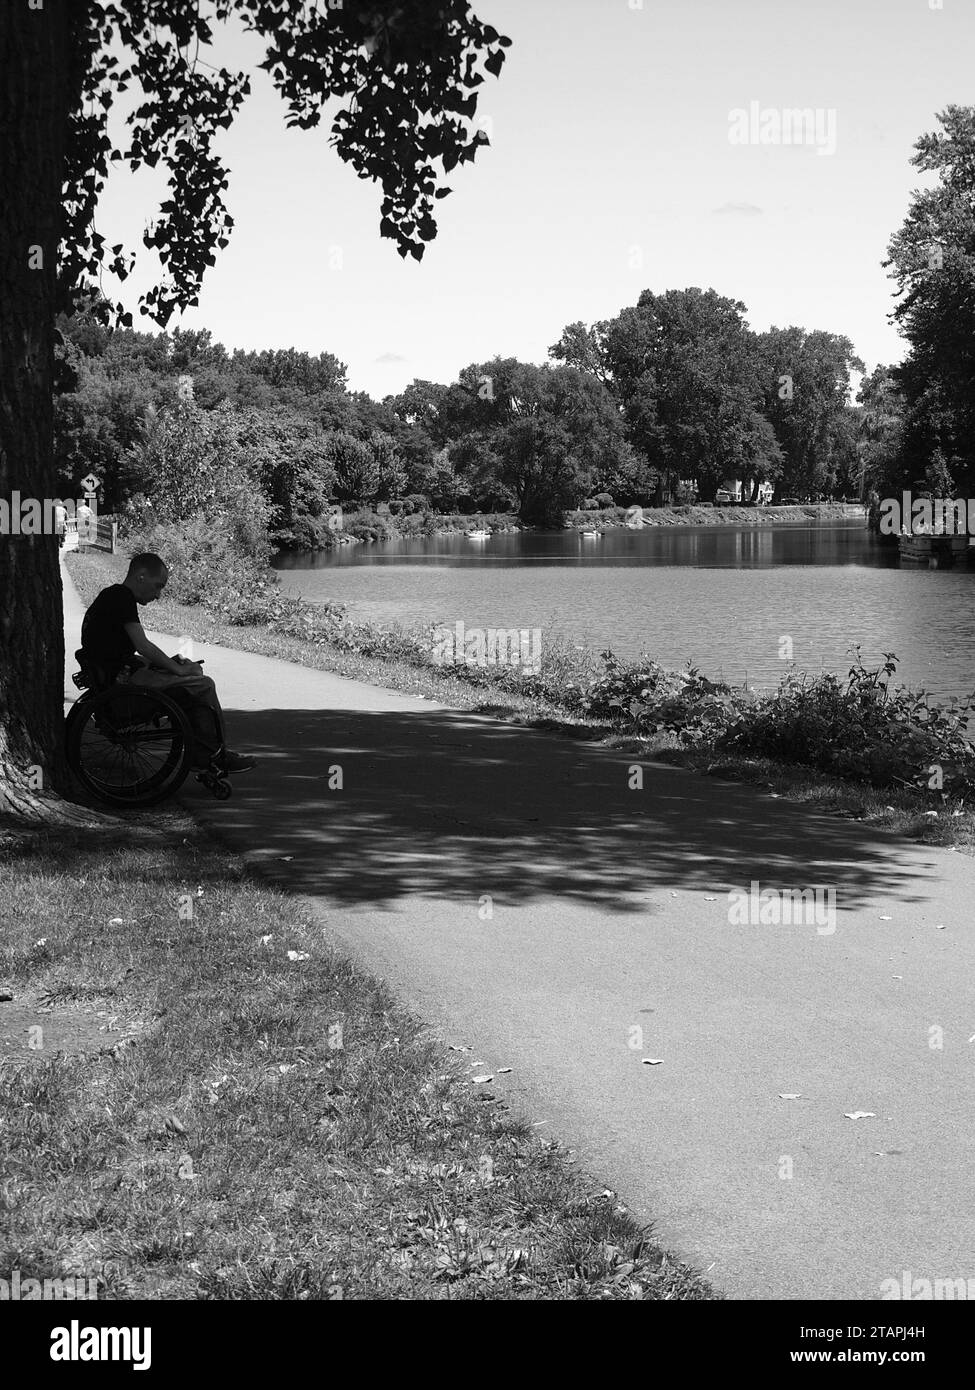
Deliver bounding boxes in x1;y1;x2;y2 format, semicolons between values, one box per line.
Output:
65;558;975;1298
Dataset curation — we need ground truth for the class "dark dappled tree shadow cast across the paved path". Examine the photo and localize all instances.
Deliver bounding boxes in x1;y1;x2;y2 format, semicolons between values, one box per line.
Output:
173;709;939;913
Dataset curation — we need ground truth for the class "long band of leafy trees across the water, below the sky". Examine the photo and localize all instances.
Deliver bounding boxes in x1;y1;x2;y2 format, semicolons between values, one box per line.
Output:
56;280;864;548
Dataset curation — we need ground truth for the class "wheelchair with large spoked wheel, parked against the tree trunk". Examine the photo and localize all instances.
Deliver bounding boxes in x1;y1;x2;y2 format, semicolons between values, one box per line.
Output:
64;648;231;806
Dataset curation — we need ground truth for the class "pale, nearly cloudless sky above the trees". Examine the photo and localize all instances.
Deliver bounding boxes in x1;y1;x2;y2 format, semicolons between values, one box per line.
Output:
97;0;975;400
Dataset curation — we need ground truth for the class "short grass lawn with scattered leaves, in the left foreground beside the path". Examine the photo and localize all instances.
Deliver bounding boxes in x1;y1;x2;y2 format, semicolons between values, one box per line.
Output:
0;809;718;1300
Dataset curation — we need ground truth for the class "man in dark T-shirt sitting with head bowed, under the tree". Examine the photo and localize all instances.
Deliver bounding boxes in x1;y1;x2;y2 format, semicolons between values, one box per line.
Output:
79;553;257;773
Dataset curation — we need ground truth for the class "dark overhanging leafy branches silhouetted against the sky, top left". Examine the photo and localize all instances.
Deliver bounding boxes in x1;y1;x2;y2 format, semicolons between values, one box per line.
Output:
60;0;510;324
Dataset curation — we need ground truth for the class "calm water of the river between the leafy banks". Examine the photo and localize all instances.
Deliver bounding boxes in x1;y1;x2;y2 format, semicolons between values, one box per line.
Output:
269;517;975;699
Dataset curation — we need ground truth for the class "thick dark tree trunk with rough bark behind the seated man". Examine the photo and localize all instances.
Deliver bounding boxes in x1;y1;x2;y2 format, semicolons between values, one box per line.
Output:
0;0;96;821
